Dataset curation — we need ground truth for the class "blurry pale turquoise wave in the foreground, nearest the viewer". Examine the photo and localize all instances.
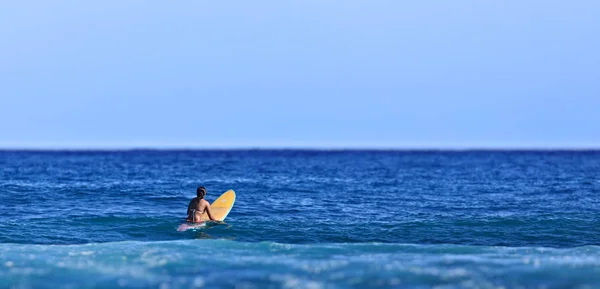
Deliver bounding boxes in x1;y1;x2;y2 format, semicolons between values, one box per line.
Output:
0;240;600;288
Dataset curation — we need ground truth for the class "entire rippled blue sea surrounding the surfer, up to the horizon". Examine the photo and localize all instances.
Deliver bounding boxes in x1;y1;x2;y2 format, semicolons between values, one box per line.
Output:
0;150;600;289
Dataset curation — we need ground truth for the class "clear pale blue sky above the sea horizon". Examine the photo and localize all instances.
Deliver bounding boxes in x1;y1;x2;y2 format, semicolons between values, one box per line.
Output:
0;0;600;148
